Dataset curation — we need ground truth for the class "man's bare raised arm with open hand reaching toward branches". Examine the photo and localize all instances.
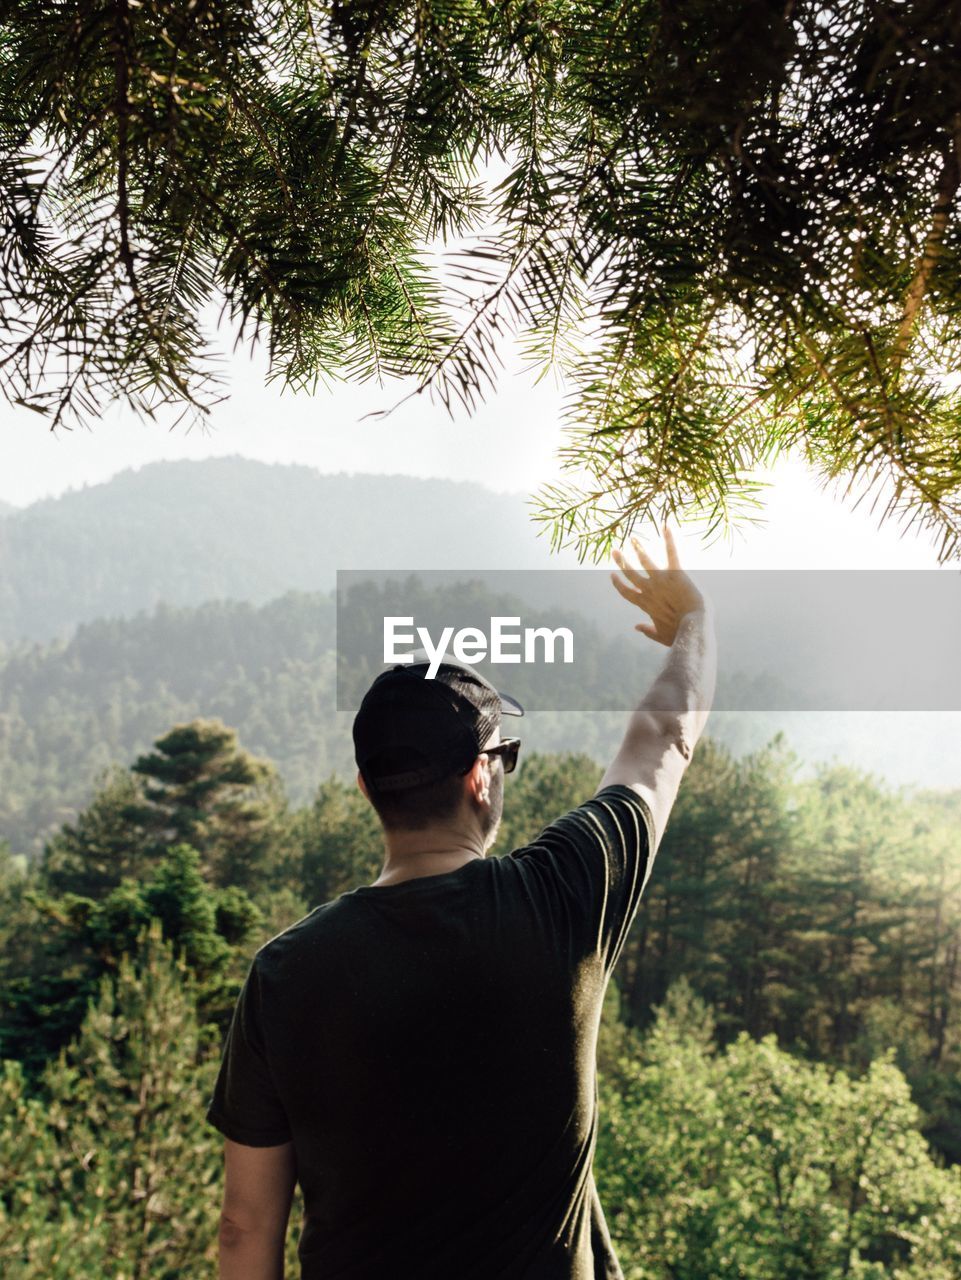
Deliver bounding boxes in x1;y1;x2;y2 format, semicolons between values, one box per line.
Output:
598;521;717;852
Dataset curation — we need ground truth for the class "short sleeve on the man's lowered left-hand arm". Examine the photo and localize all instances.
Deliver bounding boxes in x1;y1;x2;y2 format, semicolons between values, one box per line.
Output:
206;956;292;1147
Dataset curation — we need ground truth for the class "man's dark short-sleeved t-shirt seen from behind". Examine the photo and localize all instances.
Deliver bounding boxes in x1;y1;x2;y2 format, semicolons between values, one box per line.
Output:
207;786;654;1280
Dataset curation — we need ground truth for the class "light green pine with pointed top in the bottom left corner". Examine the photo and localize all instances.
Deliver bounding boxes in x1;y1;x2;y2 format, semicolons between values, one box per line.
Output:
0;928;221;1280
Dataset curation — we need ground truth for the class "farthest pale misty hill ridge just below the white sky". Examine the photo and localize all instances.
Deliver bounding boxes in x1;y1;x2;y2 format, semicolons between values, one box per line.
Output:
0;458;576;645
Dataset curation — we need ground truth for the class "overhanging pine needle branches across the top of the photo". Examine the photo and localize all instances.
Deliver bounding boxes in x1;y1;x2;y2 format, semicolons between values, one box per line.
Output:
0;0;961;559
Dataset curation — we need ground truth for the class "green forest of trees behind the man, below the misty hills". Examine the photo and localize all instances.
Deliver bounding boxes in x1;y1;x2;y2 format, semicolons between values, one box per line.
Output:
0;721;961;1280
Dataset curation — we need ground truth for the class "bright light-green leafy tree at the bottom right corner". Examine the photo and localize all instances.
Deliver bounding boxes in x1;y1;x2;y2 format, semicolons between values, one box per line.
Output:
596;986;961;1280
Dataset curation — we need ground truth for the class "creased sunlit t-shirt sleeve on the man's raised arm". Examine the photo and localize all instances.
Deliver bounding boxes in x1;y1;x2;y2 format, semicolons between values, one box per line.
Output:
511;785;655;972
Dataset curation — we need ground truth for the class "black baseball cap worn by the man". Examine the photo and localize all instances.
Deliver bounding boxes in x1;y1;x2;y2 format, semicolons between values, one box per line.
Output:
353;654;523;791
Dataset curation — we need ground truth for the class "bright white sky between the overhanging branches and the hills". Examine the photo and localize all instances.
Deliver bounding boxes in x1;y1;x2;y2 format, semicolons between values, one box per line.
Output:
0;330;957;568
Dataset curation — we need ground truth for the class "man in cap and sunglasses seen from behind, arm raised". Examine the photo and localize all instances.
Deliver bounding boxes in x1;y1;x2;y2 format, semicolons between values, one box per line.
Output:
207;526;715;1280
